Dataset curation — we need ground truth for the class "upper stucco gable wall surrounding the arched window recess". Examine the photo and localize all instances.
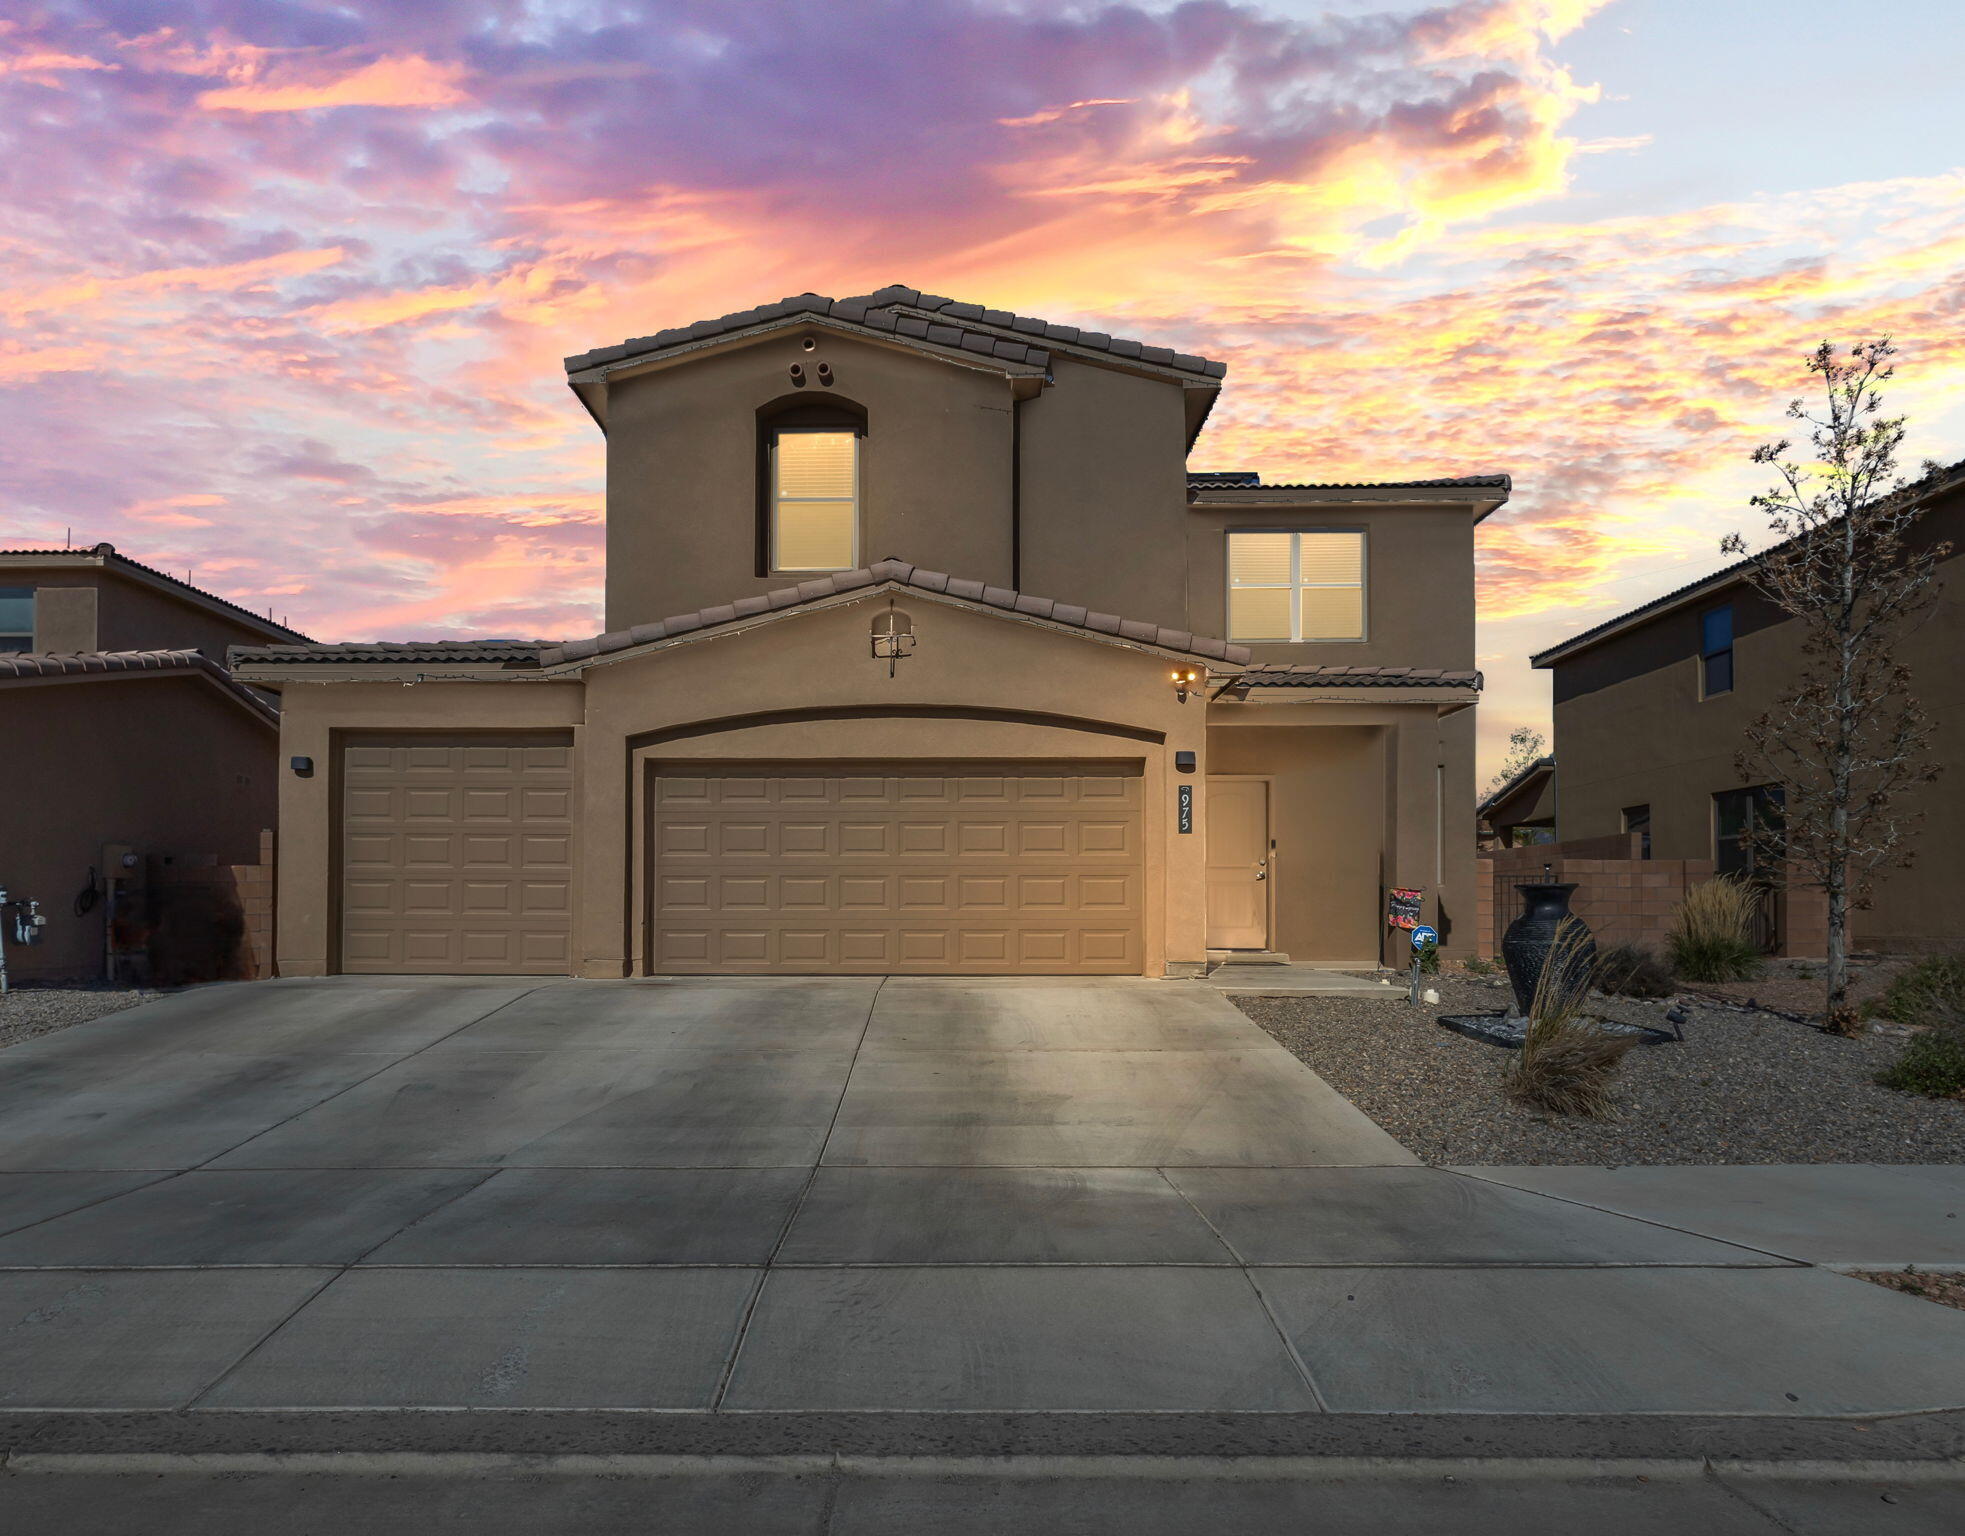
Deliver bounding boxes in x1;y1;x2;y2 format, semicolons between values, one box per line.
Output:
605;326;1021;629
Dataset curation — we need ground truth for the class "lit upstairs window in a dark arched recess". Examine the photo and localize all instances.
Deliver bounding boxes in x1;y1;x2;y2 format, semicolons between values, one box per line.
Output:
758;395;867;576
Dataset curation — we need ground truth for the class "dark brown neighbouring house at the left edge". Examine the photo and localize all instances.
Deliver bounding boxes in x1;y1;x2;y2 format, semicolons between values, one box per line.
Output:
0;544;305;980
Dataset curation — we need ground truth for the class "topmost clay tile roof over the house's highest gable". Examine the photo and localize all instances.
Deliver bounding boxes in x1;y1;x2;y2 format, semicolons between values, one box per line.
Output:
566;283;1228;379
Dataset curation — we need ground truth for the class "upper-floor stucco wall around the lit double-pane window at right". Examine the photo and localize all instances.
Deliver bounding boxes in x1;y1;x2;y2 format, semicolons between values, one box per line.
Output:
1183;507;1474;668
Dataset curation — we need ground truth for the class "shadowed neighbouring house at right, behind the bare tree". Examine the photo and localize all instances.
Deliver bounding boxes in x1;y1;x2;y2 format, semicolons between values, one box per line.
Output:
1533;462;1965;951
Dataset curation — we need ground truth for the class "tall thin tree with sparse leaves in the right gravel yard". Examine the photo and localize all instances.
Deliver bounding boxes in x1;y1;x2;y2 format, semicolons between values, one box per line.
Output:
1721;338;1949;1029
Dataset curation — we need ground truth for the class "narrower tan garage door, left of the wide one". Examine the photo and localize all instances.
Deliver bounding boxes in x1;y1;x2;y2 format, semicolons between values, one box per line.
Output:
340;735;574;976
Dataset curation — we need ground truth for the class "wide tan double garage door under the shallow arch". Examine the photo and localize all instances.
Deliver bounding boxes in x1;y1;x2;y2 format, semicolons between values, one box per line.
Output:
652;764;1144;974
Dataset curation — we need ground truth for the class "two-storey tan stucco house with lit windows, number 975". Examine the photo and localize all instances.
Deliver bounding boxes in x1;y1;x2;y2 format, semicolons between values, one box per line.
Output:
234;289;1507;976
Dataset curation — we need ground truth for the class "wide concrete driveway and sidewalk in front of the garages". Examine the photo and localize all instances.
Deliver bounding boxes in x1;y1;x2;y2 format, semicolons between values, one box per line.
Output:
0;978;1965;1418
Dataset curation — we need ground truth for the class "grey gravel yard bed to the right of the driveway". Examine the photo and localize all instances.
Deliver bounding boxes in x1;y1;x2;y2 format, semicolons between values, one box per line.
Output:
1230;974;1965;1165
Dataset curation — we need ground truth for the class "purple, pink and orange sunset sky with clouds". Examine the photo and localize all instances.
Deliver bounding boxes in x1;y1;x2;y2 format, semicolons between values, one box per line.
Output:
0;0;1965;766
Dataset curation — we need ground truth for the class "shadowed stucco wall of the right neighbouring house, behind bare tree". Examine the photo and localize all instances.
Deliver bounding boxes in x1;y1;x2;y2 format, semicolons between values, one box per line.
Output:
1554;534;1965;949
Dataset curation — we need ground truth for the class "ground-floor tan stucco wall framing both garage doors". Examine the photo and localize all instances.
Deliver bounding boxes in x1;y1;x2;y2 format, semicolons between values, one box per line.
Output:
279;595;1207;976
